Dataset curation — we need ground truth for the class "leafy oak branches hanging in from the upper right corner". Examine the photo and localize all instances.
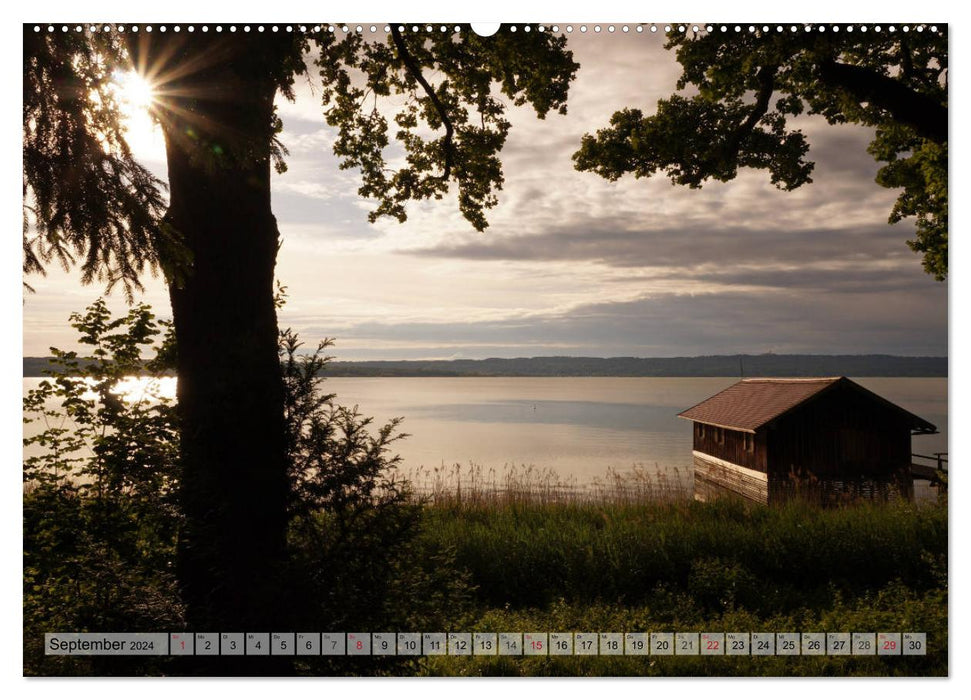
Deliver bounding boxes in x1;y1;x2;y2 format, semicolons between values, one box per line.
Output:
574;24;948;280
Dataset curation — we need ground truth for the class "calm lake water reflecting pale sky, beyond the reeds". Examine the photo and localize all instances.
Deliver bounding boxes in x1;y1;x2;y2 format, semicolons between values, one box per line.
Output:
23;377;948;494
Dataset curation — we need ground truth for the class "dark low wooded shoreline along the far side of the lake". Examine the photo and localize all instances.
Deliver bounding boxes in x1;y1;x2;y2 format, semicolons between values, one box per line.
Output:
23;354;948;378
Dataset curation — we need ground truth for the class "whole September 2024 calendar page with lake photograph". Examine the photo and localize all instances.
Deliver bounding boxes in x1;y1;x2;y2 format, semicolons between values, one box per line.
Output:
22;6;951;688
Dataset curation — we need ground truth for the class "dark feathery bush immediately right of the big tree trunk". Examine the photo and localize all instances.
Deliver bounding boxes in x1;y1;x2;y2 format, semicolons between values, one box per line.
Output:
280;330;467;673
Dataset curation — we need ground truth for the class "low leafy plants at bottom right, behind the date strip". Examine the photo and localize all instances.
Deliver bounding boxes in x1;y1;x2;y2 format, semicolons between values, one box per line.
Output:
420;581;948;678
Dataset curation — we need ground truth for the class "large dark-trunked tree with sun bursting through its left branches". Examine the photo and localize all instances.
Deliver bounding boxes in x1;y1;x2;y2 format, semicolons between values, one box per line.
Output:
23;24;577;631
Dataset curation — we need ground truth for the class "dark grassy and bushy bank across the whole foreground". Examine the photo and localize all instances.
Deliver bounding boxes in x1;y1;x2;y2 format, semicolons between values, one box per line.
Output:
24;468;948;676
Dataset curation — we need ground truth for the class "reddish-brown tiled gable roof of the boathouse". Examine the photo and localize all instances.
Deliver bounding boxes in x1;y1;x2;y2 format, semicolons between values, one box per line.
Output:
678;377;937;433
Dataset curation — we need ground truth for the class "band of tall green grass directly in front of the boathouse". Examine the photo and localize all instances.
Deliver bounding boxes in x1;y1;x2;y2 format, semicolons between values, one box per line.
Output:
428;501;947;614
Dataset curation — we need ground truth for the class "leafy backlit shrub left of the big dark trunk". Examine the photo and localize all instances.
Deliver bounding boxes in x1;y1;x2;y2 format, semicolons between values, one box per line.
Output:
24;300;183;674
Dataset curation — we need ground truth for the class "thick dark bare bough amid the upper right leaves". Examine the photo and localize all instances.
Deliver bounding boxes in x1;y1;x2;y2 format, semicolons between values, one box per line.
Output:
819;59;947;144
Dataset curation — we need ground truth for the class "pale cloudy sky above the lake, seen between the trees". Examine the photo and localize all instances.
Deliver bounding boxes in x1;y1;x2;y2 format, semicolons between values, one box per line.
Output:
23;31;948;360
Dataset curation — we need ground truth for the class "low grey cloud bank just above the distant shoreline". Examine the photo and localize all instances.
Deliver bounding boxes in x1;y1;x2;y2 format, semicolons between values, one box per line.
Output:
309;285;947;357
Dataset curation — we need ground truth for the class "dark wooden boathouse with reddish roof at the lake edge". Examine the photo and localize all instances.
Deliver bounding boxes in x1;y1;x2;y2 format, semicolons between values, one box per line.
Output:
678;377;937;503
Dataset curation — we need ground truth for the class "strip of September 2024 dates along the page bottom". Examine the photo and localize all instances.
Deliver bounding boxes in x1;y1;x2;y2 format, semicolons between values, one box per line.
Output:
45;632;927;656
